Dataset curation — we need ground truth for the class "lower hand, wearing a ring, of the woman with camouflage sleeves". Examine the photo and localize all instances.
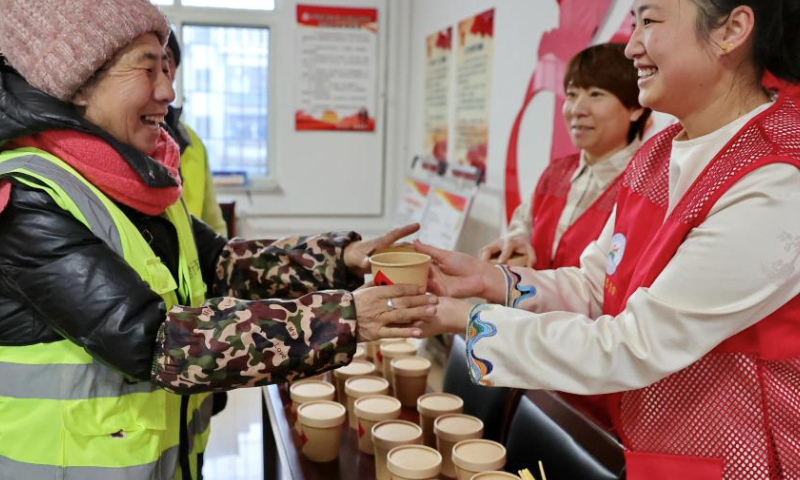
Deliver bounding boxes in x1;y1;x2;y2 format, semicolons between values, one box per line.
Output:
353;285;439;342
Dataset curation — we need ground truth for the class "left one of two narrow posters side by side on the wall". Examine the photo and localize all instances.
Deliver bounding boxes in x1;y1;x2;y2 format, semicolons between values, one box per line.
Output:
423;27;453;162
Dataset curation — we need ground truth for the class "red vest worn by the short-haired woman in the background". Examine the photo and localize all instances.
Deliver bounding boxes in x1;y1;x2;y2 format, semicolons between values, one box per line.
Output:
531;155;622;270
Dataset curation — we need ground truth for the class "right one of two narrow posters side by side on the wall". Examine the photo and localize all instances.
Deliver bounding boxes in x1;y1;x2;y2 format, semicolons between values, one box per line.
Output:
453;9;494;169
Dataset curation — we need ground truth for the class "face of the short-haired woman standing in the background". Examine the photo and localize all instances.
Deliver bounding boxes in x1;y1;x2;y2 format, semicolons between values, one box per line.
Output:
562;85;642;161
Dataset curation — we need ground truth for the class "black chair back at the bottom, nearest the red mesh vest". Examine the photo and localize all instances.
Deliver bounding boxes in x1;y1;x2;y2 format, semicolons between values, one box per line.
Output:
505;391;625;480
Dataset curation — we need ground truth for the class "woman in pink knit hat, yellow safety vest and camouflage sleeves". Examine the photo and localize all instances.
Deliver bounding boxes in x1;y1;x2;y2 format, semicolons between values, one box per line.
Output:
0;0;437;480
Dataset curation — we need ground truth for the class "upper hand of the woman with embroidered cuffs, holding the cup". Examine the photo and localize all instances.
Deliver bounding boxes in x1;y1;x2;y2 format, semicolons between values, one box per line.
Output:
414;241;505;301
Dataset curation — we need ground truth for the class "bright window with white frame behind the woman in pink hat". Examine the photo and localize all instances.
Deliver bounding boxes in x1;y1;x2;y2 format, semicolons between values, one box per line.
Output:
154;0;275;179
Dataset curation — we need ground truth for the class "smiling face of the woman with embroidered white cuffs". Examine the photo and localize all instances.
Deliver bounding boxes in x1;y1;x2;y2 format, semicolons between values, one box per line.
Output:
625;0;719;118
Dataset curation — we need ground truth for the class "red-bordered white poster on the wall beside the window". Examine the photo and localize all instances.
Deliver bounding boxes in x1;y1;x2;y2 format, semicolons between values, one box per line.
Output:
295;5;378;132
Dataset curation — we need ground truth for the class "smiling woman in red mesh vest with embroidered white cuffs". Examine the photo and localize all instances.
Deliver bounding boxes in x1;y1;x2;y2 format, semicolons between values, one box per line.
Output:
418;0;800;480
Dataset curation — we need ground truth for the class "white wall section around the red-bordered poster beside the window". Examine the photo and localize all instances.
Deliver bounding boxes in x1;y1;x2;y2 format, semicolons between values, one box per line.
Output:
218;0;404;238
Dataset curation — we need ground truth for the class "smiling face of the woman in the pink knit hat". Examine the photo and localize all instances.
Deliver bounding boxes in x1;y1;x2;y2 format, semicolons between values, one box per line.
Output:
73;33;175;154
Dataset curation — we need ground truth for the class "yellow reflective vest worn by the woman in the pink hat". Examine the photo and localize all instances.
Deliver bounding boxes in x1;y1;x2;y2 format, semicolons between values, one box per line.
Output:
0;148;211;480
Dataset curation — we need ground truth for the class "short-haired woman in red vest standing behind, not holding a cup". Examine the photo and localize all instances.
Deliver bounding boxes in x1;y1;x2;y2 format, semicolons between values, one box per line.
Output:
480;43;650;270
